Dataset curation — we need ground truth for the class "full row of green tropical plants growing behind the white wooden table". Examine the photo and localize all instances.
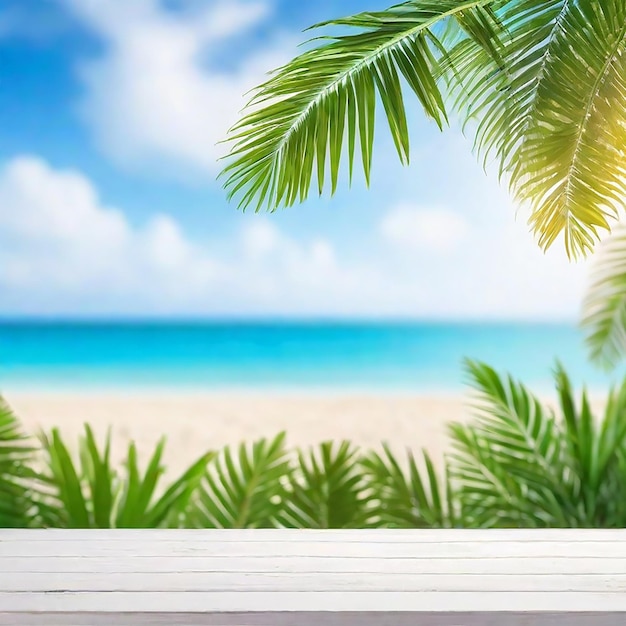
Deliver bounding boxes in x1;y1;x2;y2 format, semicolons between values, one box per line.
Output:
0;362;626;528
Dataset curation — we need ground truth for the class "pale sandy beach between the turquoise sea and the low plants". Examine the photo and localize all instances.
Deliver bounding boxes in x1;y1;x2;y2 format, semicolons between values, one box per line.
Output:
6;391;469;473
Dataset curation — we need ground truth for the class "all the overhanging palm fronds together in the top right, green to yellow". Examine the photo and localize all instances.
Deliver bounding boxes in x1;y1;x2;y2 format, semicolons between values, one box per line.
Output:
223;0;626;256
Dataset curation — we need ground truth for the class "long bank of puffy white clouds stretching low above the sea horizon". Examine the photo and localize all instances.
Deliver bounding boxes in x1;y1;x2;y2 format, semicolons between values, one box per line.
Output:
0;156;586;319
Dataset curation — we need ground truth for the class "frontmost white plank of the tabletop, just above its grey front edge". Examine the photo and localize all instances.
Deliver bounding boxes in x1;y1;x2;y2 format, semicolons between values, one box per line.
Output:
0;591;626;608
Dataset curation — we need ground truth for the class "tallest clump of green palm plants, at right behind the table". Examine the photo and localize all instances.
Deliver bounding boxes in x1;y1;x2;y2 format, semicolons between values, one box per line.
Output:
450;362;626;528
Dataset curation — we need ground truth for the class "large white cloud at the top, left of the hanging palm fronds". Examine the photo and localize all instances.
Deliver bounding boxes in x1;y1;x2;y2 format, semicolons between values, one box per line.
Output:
62;0;294;178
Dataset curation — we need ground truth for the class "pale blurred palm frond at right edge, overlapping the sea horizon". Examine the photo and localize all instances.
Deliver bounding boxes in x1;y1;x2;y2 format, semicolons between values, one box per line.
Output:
582;226;626;369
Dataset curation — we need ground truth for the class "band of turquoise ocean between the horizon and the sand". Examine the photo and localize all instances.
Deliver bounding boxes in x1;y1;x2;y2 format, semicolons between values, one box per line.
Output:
0;322;618;393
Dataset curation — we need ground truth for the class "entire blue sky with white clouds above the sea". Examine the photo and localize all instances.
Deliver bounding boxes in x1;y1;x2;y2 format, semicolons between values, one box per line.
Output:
0;0;587;319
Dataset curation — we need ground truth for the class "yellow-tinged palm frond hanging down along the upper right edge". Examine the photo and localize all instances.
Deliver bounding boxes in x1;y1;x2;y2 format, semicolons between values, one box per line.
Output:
504;0;626;256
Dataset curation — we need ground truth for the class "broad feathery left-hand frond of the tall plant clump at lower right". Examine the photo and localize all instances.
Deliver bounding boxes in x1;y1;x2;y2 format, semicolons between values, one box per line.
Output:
451;361;576;526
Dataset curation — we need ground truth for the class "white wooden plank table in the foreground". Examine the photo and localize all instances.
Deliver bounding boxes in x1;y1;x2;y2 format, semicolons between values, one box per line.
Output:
0;530;626;626
